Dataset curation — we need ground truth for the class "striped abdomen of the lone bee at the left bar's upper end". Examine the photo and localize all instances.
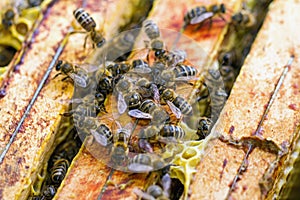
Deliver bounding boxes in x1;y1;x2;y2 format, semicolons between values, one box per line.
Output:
73;8;96;32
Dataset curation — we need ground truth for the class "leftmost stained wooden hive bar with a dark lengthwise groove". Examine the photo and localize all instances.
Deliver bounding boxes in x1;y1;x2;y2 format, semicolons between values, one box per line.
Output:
0;0;139;199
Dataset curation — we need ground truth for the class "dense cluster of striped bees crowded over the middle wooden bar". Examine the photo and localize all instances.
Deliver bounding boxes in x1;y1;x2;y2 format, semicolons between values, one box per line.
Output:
52;8;220;175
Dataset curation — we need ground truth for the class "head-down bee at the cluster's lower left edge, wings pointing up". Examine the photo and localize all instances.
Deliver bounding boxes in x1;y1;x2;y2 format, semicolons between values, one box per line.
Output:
111;124;131;165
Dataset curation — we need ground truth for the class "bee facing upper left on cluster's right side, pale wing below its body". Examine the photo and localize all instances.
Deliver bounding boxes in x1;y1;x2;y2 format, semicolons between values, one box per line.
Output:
161;89;193;119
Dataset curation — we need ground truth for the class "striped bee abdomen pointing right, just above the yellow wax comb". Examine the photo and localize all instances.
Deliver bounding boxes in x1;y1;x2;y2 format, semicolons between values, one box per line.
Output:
159;125;185;140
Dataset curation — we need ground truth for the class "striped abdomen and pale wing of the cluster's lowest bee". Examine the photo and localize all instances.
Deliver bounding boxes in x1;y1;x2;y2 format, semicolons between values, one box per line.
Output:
127;154;153;173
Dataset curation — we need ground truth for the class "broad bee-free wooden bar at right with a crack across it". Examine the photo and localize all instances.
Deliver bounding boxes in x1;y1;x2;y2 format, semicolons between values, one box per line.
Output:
191;0;300;199
